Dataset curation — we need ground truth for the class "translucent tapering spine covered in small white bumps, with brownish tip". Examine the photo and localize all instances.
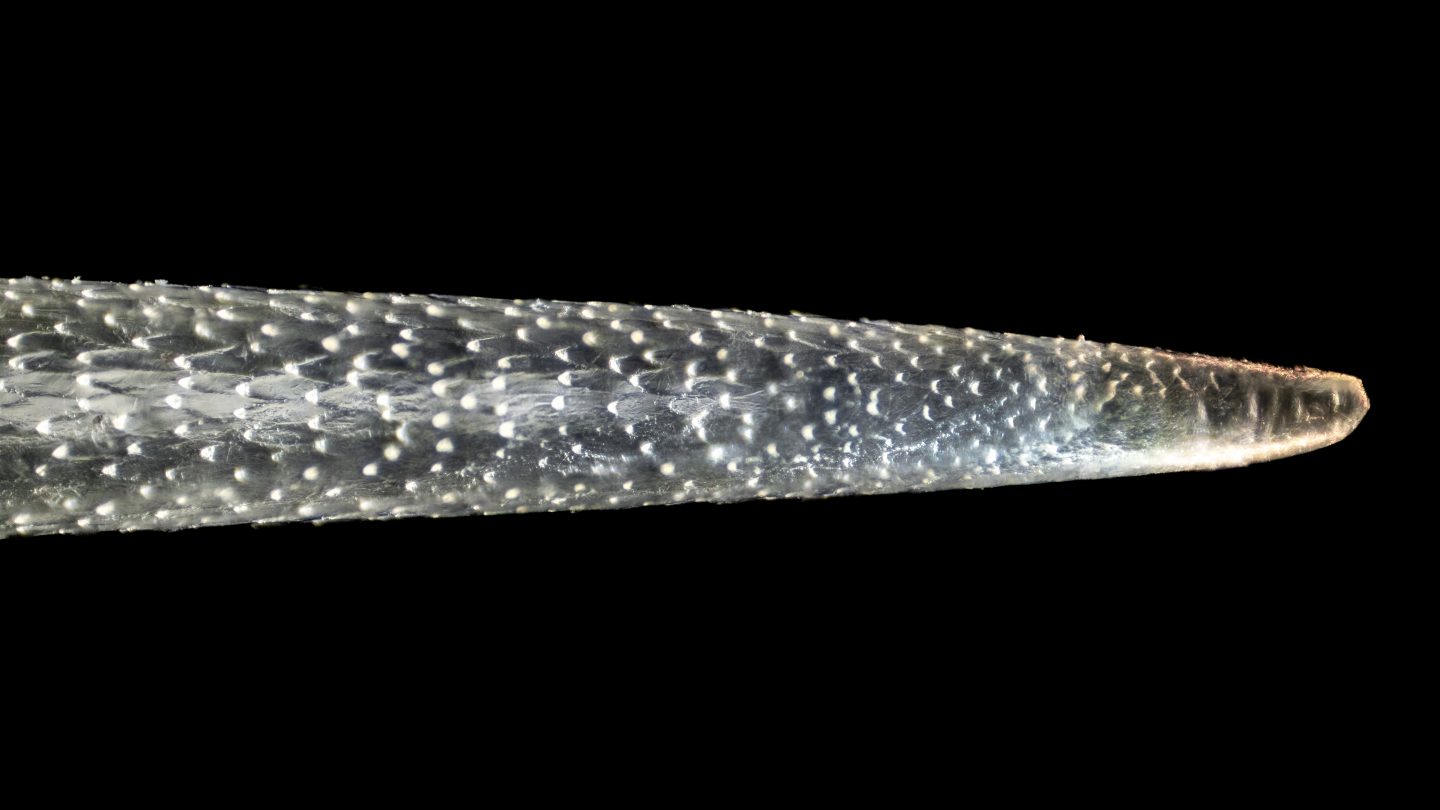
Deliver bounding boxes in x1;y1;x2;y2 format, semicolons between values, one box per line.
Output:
0;278;1369;536
